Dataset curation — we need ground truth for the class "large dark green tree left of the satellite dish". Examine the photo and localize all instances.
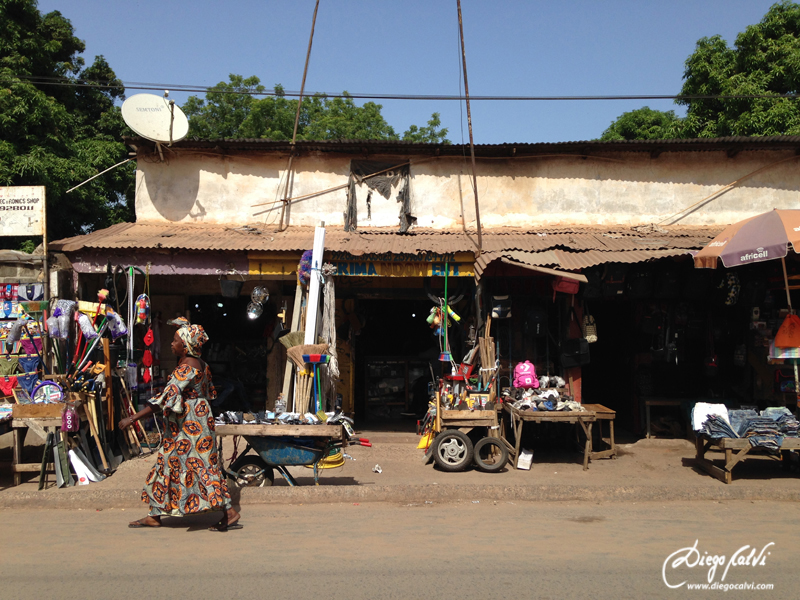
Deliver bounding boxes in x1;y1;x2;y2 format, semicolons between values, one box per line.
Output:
0;0;134;247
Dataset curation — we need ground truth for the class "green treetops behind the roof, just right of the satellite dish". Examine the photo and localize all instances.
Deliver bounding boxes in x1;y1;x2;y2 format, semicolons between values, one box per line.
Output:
183;74;449;143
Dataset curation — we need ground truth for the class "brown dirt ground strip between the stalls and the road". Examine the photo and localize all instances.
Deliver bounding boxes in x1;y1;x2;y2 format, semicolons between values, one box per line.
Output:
0;431;800;491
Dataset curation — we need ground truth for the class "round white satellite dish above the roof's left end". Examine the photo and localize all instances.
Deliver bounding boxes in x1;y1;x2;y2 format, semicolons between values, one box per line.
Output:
122;94;189;144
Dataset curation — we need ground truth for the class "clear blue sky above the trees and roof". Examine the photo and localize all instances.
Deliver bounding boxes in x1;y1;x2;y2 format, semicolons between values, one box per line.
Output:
39;0;773;144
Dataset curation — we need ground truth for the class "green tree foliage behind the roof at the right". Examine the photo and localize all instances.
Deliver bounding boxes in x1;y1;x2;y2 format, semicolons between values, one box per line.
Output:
601;0;800;139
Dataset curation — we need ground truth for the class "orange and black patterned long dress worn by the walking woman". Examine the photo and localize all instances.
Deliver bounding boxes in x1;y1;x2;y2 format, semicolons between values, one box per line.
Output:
142;365;231;517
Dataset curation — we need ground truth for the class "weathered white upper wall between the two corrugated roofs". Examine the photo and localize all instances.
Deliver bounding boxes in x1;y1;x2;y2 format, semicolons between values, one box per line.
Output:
136;151;800;229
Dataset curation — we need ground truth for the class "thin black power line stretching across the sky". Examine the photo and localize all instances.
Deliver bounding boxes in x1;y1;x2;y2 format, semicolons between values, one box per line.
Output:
0;76;800;102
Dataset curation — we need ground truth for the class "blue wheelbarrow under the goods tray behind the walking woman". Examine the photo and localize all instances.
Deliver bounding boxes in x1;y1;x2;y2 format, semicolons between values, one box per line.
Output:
224;435;372;487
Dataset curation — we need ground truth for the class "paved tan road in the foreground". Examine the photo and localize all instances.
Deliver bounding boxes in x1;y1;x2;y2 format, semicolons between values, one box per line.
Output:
0;500;800;600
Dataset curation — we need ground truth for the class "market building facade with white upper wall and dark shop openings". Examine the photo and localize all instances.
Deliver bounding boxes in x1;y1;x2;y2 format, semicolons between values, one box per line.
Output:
51;137;800;431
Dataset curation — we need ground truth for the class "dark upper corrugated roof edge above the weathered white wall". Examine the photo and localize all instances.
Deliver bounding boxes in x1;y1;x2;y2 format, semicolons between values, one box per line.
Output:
123;135;800;157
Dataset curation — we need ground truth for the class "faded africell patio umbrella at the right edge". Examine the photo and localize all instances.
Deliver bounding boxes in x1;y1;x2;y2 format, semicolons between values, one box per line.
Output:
694;209;800;398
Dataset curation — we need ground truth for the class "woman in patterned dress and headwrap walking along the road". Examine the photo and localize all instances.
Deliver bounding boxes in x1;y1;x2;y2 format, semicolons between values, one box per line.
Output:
119;317;242;531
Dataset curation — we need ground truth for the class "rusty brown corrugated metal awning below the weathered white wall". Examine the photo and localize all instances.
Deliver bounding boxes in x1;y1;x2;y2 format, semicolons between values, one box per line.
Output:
50;223;722;277
